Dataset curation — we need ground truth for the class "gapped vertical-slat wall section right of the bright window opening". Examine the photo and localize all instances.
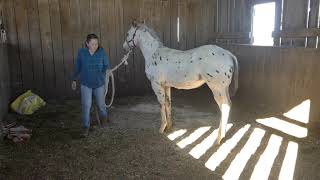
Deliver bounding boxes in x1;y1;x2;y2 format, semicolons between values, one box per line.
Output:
273;0;320;48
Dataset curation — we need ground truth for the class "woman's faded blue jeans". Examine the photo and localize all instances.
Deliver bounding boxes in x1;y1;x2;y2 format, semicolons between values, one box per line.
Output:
81;85;108;128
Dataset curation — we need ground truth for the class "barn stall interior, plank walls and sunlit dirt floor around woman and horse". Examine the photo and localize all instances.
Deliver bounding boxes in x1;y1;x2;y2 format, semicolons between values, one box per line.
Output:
0;0;320;179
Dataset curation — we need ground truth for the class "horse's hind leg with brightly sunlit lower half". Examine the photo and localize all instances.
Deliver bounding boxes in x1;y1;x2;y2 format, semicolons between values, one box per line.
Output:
208;84;231;144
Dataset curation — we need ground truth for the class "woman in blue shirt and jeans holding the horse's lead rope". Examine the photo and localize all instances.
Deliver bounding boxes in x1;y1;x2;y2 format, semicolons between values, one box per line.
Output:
72;34;109;137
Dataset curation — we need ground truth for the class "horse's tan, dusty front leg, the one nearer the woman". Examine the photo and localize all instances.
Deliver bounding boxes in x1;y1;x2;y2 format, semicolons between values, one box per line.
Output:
152;82;168;133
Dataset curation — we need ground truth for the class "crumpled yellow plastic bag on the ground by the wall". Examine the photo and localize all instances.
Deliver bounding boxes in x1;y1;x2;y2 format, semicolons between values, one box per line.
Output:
11;90;46;115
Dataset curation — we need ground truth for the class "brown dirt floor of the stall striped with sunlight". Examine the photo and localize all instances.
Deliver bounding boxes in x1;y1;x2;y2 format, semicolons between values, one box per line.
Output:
0;88;320;180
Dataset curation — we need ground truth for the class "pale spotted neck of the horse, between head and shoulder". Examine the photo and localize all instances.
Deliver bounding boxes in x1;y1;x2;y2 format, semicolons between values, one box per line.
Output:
139;32;161;63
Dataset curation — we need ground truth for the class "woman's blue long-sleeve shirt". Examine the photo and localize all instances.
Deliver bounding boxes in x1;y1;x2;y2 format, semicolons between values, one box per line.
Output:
72;48;109;88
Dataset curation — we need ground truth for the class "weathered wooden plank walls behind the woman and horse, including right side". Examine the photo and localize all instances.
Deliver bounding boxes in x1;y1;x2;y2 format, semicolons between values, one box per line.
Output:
0;0;320;124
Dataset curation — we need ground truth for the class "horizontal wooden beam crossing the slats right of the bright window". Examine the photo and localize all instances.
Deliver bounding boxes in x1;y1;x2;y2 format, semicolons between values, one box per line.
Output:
272;28;320;38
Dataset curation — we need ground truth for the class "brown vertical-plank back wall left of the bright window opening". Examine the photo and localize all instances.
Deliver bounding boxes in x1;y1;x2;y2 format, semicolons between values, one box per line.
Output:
0;0;250;98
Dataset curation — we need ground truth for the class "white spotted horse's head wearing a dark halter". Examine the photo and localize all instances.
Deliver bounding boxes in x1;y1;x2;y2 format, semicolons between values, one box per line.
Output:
123;20;141;51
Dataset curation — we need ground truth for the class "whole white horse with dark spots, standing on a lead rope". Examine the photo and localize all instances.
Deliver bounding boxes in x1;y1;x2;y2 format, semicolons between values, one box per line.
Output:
123;23;239;143
